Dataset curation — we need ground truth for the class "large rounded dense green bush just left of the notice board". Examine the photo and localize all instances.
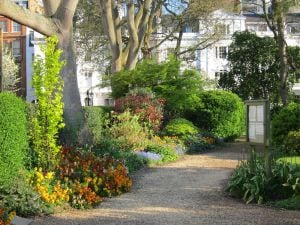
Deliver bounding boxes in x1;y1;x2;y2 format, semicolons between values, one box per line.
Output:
187;90;245;140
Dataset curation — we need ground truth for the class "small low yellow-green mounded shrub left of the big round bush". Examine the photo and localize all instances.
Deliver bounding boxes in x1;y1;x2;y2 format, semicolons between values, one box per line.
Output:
163;118;199;139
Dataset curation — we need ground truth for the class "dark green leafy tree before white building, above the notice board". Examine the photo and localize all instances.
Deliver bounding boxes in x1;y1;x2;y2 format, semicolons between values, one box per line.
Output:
219;31;279;103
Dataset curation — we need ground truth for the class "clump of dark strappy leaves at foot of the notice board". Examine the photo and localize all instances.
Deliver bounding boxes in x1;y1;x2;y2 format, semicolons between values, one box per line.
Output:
227;157;300;203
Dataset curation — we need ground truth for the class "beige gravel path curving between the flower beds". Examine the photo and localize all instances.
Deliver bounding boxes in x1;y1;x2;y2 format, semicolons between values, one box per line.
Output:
32;144;300;225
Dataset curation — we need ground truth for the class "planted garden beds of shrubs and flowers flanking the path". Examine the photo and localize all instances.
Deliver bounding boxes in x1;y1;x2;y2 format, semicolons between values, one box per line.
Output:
0;37;300;224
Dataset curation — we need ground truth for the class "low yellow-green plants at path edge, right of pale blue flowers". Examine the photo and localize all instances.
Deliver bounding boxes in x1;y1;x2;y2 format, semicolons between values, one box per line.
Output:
145;144;178;162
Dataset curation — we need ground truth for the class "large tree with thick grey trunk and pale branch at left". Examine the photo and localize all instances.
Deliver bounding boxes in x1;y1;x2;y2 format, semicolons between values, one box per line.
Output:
0;0;84;140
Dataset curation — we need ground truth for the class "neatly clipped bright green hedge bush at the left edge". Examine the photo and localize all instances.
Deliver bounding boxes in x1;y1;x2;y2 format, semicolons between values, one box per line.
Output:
0;93;28;185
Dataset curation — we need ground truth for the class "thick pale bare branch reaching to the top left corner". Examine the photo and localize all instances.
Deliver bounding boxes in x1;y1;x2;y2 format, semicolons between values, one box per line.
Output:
0;0;58;36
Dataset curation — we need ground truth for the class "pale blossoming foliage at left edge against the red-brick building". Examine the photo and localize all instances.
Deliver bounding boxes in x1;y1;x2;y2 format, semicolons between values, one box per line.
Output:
2;48;20;92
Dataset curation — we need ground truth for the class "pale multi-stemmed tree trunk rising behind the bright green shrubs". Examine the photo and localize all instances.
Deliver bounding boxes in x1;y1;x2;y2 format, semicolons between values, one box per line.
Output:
95;0;164;73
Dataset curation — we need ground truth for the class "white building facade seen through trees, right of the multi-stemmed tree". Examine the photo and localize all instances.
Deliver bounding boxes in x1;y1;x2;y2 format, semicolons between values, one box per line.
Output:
154;6;300;93
